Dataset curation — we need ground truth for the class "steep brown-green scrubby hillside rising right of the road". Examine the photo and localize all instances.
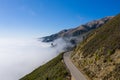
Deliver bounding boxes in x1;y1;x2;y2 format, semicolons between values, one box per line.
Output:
71;14;120;80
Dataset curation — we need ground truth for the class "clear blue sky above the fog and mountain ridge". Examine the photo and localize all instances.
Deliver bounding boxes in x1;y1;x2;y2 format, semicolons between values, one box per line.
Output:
0;0;120;38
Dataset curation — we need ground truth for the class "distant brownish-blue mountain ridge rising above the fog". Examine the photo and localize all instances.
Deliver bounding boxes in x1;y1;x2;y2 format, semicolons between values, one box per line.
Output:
42;16;113;42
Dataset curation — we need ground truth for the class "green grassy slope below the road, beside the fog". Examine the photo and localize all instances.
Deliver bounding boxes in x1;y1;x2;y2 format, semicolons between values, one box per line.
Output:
20;53;70;80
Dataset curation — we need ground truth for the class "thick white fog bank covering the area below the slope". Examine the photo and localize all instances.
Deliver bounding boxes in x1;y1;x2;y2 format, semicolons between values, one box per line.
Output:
0;38;70;80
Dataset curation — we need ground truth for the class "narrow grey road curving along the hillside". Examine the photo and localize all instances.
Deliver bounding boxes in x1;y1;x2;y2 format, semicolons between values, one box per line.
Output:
63;52;87;80
